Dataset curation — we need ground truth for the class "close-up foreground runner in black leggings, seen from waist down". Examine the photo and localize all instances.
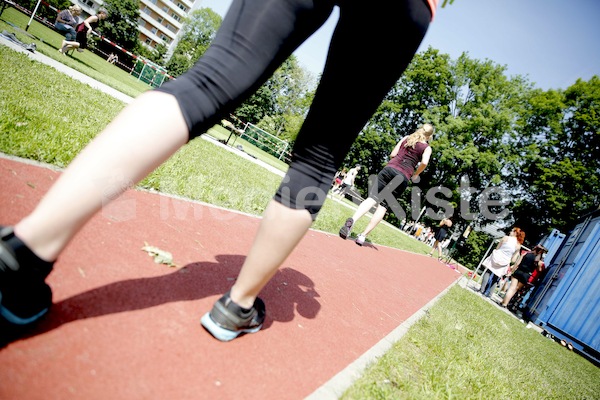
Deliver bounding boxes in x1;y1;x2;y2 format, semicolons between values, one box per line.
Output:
0;0;438;341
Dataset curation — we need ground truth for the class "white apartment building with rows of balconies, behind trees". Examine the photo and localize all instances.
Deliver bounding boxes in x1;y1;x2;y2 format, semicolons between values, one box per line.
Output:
72;0;202;53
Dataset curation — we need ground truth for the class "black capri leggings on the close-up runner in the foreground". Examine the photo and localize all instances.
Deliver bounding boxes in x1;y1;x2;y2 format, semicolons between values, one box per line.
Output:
156;0;431;218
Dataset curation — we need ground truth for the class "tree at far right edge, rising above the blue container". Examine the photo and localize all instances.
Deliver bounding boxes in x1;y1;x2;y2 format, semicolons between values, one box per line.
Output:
514;76;600;244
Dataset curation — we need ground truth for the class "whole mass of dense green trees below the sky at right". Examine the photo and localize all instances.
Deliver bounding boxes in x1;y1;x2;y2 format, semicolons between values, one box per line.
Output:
345;48;600;253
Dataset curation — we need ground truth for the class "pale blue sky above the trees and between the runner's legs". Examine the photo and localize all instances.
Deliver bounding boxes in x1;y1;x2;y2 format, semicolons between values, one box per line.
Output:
200;0;600;90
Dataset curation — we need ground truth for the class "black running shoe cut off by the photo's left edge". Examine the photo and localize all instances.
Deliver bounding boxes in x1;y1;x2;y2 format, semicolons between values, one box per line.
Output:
0;227;52;347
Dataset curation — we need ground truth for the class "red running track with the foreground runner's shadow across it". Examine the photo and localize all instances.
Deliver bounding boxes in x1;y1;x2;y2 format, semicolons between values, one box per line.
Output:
0;158;460;400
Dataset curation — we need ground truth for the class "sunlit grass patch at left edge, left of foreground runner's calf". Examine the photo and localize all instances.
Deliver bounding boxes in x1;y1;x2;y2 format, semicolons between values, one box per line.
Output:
0;46;123;167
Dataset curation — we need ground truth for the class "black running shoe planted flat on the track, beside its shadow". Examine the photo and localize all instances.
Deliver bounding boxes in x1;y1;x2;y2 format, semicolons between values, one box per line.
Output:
201;292;266;342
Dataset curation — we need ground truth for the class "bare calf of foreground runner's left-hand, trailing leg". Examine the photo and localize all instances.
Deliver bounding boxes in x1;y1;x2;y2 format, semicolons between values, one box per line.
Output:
15;92;188;261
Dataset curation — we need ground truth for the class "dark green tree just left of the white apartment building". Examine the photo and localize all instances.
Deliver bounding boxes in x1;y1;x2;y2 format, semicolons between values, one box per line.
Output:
99;0;140;52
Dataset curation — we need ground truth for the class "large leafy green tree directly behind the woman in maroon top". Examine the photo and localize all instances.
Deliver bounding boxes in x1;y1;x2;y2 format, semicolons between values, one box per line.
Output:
346;48;527;228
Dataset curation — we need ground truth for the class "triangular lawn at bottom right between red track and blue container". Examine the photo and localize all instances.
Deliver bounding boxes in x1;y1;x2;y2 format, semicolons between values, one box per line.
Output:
341;286;600;400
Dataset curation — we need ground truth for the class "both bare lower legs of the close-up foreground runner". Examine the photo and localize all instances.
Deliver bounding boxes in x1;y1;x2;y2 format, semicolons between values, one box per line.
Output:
15;92;312;308
